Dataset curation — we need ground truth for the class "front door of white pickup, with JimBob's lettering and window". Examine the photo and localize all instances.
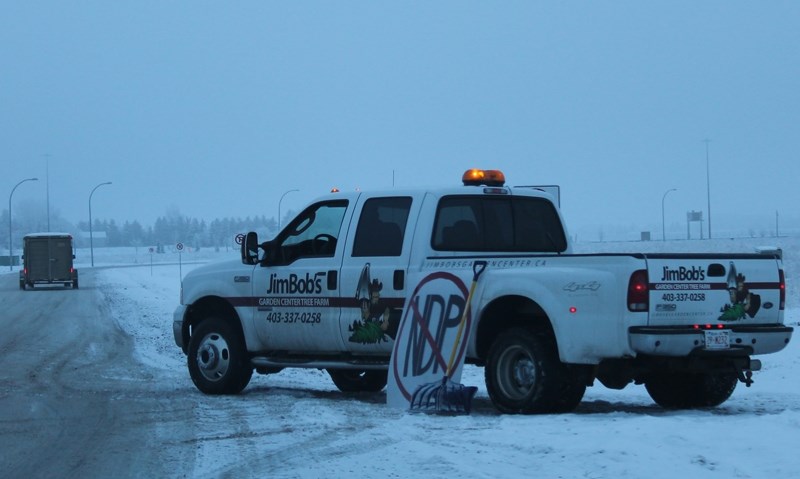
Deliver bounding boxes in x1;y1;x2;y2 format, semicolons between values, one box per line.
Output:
253;199;348;351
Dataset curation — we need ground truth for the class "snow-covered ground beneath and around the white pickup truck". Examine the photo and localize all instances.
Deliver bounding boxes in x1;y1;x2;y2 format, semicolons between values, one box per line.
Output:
78;238;800;478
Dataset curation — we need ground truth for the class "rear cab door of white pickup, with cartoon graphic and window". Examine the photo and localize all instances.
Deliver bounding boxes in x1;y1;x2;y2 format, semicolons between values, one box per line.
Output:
340;195;419;354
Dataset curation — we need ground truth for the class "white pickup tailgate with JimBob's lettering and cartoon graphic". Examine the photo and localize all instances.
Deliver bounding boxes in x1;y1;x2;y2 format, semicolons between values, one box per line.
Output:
646;254;783;327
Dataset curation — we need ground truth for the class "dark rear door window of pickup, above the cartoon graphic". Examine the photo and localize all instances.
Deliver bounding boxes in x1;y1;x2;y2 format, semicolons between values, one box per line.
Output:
353;196;411;256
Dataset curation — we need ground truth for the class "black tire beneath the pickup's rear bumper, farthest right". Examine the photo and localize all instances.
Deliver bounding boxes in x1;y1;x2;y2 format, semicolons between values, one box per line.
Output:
645;373;739;409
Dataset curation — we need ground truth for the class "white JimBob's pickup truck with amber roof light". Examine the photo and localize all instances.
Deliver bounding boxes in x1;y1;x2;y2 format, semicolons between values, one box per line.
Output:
173;170;793;413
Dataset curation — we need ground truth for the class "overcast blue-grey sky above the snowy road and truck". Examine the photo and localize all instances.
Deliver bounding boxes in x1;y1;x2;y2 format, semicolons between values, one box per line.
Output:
0;0;800;239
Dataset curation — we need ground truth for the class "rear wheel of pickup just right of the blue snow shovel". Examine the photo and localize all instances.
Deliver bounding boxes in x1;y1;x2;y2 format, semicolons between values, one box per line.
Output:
484;328;564;414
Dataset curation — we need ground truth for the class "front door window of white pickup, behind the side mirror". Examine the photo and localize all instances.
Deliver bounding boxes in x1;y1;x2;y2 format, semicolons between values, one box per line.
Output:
275;200;347;264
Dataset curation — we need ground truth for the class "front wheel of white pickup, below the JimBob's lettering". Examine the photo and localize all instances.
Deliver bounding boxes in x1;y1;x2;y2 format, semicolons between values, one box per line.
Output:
187;317;253;394
